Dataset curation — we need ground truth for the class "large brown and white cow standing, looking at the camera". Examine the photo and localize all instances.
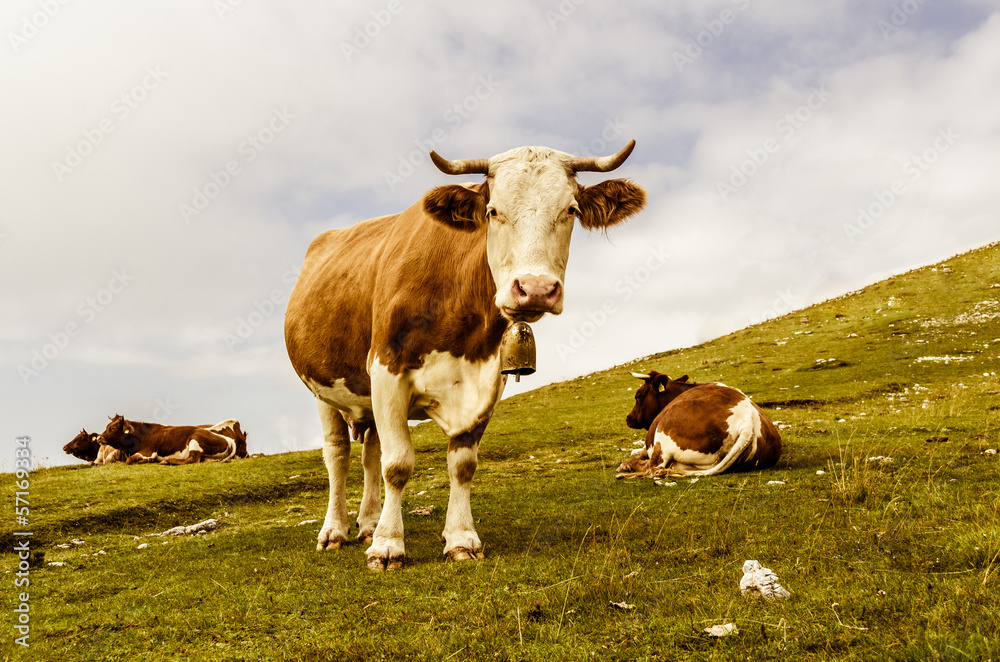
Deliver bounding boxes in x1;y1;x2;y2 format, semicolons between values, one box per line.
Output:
285;141;645;570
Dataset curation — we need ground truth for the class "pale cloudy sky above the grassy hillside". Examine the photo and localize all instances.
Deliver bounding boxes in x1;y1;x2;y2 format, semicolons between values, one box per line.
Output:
0;0;1000;471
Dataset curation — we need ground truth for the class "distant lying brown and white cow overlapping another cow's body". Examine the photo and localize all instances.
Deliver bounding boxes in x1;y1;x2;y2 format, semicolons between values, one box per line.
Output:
99;415;247;464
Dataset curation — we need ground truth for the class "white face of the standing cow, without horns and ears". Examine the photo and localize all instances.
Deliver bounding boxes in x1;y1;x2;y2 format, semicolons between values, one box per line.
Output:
486;148;579;322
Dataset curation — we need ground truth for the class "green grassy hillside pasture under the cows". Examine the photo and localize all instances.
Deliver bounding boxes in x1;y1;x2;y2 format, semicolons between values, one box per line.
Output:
0;246;1000;661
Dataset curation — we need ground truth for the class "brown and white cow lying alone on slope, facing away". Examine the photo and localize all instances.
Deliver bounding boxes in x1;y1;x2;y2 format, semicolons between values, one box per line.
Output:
618;371;781;476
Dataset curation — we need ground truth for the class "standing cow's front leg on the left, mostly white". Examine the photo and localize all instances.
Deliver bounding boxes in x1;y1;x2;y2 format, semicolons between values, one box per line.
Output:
367;359;414;571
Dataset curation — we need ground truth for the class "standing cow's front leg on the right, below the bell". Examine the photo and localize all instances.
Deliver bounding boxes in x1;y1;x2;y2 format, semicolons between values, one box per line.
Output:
441;421;488;561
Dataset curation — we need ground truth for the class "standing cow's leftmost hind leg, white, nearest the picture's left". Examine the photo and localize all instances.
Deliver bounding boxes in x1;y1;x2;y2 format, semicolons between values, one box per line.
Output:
316;399;351;551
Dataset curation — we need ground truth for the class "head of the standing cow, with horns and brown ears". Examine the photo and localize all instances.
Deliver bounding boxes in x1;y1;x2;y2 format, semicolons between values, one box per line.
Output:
424;140;646;322
